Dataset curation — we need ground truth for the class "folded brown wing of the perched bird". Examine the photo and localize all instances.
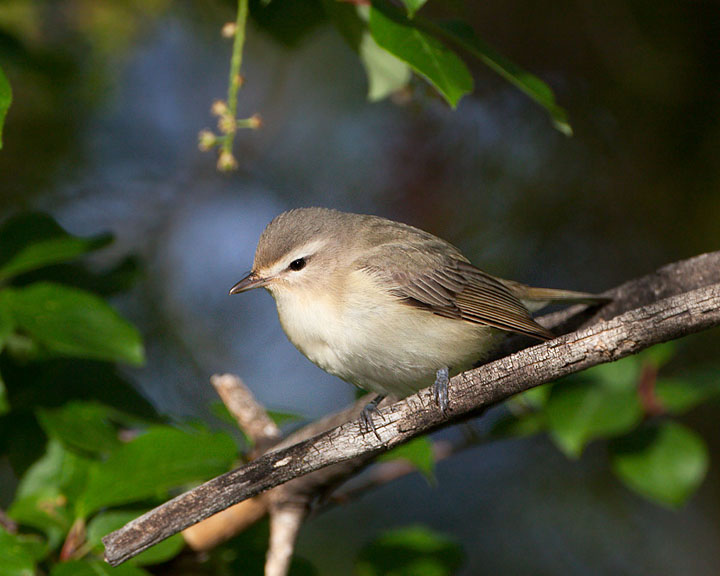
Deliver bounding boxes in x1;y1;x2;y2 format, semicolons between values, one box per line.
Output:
355;238;553;340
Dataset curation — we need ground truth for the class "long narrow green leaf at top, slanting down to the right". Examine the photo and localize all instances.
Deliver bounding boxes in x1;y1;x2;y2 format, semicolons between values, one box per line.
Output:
430;21;572;136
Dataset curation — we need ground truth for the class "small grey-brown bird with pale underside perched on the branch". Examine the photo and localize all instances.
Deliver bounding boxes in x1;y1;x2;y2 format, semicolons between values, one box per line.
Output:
230;208;601;429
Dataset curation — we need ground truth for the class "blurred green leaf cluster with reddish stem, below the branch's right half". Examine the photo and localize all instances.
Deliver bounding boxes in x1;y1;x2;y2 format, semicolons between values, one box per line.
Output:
492;343;720;508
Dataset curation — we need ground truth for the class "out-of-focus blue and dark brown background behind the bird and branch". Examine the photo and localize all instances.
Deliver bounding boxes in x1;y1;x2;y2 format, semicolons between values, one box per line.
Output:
0;0;720;575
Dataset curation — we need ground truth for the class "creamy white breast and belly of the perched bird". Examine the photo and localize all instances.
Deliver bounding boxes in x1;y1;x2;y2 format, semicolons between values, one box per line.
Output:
273;271;494;397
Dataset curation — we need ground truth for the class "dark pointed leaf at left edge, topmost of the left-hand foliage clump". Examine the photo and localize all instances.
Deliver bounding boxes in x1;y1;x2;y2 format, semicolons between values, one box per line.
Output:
0;212;112;281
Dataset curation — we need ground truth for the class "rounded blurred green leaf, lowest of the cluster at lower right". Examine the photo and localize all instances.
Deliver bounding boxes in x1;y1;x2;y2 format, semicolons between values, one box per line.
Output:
610;422;709;507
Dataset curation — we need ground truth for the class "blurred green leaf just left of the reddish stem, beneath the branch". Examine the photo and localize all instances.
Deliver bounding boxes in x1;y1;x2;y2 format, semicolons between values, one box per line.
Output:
546;381;642;458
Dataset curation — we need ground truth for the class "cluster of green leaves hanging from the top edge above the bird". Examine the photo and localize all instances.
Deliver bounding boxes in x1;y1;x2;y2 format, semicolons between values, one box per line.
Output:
250;0;572;135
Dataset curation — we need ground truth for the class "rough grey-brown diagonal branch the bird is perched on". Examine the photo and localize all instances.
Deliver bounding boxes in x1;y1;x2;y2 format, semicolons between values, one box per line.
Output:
103;252;720;565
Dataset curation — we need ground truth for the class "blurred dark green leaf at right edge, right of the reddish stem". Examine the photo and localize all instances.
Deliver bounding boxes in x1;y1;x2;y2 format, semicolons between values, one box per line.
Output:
655;368;720;414
